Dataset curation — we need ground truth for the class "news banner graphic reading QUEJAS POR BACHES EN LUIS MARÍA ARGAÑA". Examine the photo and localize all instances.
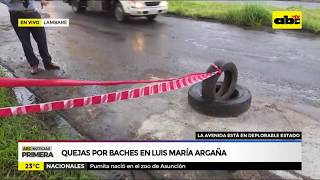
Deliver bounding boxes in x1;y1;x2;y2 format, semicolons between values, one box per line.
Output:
18;132;302;171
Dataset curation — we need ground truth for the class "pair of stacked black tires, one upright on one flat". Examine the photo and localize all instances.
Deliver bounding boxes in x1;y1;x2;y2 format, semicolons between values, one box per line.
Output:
188;61;251;117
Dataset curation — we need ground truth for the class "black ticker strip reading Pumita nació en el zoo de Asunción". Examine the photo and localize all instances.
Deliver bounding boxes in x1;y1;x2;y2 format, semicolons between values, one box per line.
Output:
87;162;302;170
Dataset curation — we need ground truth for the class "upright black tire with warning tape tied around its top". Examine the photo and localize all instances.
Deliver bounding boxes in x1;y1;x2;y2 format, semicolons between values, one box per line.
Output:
202;61;238;100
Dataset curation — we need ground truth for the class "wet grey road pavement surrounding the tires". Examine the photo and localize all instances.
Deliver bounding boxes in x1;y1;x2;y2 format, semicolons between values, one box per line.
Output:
0;2;320;179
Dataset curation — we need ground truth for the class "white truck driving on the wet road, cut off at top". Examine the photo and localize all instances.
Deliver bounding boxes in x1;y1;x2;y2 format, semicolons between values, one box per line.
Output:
67;0;168;22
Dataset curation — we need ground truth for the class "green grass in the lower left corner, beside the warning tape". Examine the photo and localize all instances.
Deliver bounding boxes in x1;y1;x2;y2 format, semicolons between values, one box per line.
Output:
0;69;97;179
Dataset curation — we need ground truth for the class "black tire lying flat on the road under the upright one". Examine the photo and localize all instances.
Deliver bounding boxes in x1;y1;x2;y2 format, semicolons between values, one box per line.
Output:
188;83;251;117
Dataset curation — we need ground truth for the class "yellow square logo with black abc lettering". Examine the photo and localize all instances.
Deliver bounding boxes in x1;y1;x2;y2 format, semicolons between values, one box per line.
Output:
272;11;302;29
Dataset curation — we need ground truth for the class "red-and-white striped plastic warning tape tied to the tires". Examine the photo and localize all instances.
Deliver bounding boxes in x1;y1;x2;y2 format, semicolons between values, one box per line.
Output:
0;69;221;117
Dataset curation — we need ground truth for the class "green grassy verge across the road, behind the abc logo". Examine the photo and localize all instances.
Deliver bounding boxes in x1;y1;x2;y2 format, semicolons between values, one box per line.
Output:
169;1;320;33
